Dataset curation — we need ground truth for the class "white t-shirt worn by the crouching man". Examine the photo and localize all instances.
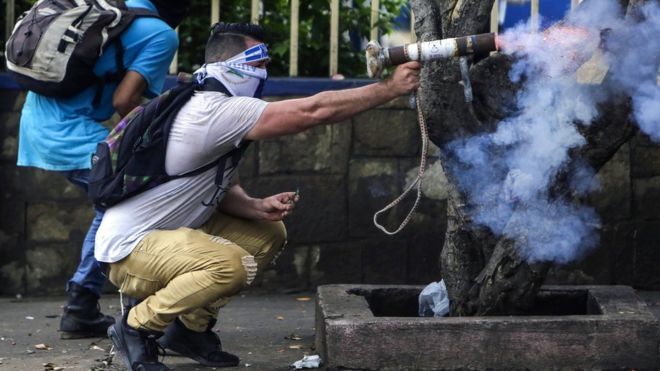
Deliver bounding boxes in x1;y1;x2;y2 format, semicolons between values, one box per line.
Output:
94;92;268;263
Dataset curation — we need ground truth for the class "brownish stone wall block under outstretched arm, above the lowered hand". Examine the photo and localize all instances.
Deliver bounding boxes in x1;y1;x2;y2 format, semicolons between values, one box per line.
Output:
259;122;351;174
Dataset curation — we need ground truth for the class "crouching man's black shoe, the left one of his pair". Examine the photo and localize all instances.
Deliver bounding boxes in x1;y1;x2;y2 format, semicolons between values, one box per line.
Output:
108;312;169;371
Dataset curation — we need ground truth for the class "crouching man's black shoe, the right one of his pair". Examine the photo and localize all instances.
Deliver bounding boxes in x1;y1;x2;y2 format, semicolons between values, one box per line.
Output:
158;318;239;367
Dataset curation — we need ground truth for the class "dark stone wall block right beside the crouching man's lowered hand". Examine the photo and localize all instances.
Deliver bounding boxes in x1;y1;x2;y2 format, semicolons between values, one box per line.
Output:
243;175;348;244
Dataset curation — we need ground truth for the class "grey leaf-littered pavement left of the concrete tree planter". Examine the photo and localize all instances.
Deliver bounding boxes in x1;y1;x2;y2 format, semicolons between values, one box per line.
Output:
0;292;316;371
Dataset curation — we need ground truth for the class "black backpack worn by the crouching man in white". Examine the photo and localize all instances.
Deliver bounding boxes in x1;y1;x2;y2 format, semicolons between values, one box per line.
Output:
88;79;249;209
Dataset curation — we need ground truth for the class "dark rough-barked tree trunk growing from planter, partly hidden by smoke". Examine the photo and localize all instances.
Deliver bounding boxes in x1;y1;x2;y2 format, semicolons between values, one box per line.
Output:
411;0;639;316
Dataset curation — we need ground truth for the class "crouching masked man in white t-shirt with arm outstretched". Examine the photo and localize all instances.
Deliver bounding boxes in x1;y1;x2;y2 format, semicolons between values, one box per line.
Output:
95;23;421;370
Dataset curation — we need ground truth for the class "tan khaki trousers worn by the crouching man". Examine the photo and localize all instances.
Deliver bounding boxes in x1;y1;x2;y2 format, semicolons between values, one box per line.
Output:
109;213;286;332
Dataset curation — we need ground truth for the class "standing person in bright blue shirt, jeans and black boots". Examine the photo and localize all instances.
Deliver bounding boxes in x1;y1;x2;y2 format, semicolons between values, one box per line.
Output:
17;0;189;339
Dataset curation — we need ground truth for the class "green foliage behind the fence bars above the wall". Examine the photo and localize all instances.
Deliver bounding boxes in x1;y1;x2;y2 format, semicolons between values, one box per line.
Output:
179;0;407;77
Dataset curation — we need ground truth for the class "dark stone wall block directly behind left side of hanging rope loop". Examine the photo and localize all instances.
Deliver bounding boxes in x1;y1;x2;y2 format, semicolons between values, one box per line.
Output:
348;159;403;237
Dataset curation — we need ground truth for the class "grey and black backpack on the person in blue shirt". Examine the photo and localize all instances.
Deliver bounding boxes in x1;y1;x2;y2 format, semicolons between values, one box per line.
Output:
5;0;158;102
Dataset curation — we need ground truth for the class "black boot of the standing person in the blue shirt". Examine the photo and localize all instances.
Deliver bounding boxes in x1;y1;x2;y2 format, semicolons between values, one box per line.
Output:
60;283;115;339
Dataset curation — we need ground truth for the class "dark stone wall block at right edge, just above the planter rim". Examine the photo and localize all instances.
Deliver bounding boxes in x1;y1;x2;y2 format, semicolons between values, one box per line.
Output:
634;222;660;290
